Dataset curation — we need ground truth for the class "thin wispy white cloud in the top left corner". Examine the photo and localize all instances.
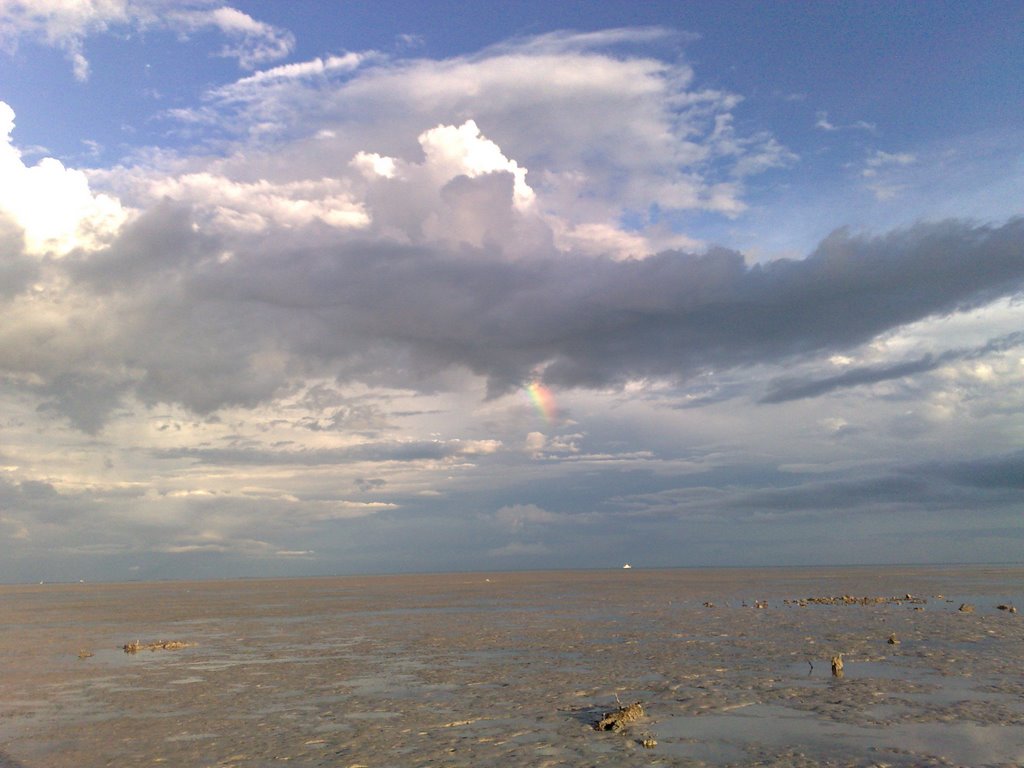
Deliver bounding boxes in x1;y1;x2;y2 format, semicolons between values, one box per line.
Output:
0;0;295;81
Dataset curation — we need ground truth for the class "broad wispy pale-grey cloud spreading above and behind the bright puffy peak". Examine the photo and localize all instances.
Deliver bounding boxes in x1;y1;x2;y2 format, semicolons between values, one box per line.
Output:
175;30;782;227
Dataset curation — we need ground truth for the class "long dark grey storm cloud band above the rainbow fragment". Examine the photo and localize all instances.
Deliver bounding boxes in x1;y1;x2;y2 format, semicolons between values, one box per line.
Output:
28;214;1024;426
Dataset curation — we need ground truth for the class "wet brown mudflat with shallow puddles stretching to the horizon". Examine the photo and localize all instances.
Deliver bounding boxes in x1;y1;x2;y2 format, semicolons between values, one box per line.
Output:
0;566;1024;768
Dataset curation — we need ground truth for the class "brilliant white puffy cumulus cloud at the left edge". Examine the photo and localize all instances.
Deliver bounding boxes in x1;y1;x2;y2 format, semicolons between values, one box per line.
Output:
0;101;129;255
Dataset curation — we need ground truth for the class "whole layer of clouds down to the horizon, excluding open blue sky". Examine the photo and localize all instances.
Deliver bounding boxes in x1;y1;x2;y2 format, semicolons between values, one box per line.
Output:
0;20;1024;578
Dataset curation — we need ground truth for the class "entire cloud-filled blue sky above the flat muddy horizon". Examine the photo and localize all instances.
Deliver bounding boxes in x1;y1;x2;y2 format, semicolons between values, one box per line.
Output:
0;0;1024;582
